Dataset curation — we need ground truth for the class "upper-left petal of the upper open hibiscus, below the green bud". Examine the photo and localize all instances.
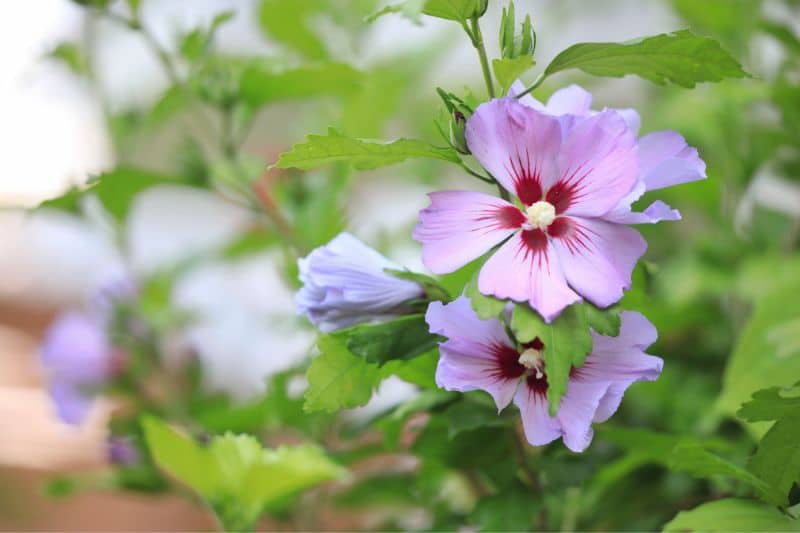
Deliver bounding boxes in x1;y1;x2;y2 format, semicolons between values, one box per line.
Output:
465;98;561;205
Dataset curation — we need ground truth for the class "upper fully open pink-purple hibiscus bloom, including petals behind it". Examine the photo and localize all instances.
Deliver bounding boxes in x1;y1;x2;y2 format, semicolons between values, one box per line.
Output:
414;89;704;322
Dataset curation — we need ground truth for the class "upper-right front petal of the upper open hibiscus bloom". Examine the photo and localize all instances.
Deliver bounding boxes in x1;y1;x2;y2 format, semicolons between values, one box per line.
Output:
542;110;638;216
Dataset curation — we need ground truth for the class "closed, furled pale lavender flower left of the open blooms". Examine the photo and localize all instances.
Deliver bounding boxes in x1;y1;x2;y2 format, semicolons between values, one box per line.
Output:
295;233;424;332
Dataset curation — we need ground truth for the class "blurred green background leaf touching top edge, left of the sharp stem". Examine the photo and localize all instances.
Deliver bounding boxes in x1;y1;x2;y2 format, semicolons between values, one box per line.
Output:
258;0;328;59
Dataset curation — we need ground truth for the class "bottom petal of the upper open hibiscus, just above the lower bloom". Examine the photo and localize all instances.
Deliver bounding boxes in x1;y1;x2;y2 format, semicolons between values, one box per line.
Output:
478;230;580;322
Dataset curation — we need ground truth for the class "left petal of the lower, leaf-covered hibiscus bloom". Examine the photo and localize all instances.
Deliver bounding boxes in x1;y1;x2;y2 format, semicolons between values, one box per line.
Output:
425;296;524;410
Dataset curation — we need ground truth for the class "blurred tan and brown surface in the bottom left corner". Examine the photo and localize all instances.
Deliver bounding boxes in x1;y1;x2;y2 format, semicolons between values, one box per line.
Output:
0;305;215;531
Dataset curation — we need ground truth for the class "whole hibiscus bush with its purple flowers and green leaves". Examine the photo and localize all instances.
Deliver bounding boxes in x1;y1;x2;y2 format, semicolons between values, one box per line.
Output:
29;0;800;531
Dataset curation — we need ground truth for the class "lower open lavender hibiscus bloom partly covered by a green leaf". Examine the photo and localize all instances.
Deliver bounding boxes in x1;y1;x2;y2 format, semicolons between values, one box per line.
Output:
425;297;663;452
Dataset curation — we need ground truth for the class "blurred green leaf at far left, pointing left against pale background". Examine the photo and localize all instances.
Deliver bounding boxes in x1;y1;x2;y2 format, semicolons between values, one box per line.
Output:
37;167;187;221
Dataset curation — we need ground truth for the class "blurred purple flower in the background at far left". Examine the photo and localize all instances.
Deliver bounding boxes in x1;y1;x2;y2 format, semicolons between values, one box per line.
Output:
41;311;116;424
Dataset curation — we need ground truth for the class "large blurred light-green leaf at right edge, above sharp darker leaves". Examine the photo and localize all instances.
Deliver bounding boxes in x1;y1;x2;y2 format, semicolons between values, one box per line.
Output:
716;282;800;434
